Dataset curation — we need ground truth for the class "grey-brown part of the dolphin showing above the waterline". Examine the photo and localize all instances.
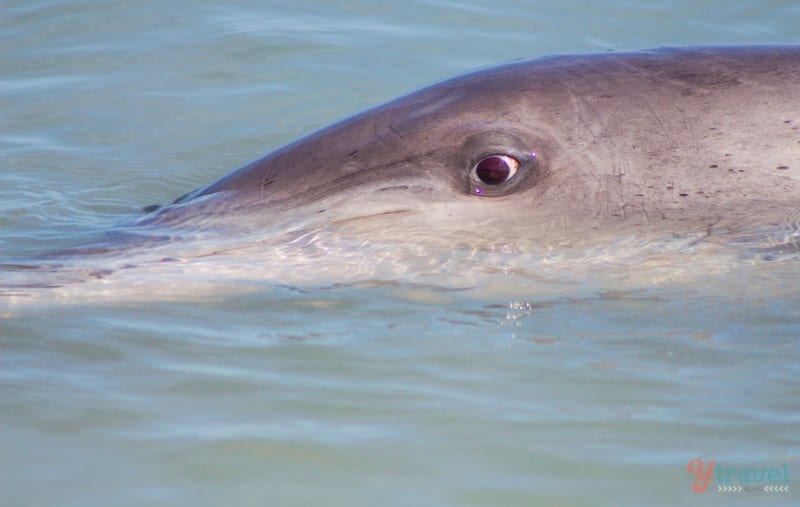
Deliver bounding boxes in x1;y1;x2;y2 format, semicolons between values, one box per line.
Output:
141;45;800;239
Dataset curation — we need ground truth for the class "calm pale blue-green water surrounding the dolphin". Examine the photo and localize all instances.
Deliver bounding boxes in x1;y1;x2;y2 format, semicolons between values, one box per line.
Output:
0;1;800;506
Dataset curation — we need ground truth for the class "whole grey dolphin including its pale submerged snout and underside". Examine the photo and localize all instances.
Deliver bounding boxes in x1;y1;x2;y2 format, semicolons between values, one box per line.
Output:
0;45;800;300
